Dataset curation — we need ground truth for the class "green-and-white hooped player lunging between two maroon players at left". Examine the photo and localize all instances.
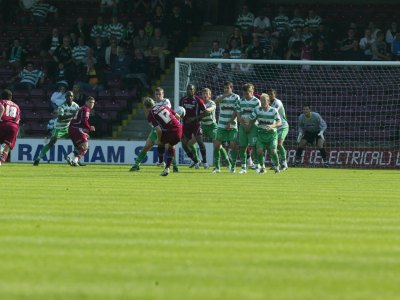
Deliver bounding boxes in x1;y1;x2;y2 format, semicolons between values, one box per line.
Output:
33;91;79;166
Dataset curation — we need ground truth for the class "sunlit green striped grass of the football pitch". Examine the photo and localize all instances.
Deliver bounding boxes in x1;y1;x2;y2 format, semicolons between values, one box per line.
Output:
0;163;400;300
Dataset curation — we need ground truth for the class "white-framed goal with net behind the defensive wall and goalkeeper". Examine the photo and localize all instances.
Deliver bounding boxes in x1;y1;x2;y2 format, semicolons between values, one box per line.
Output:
174;58;400;168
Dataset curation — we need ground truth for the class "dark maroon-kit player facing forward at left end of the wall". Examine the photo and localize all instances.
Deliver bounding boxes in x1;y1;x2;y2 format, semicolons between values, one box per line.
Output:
179;84;208;169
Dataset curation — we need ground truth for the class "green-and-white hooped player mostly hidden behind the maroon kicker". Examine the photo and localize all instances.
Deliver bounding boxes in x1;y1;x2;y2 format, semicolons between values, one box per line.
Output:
130;87;179;172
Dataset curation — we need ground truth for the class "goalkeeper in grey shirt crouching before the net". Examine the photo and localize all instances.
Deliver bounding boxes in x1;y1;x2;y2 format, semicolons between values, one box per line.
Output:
295;104;329;167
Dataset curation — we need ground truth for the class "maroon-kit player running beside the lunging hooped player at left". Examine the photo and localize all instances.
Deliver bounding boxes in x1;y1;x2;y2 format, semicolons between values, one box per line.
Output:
65;97;96;167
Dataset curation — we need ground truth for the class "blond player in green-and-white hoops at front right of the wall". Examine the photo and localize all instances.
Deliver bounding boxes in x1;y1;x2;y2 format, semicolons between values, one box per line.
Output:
249;94;282;174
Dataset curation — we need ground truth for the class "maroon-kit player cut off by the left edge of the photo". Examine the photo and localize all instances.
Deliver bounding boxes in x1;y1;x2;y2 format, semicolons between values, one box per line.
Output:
0;89;21;166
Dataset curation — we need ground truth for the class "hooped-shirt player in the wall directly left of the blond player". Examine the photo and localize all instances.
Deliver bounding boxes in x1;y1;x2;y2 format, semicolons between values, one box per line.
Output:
236;83;261;174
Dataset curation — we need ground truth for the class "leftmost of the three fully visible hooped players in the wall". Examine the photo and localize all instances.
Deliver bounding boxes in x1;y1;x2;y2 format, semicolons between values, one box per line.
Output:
213;81;240;173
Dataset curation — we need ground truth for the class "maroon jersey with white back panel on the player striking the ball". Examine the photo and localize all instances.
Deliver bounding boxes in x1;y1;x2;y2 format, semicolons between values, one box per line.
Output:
147;105;182;131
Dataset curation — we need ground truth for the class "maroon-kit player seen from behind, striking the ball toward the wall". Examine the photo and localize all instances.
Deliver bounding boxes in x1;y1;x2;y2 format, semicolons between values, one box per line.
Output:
143;98;182;176
